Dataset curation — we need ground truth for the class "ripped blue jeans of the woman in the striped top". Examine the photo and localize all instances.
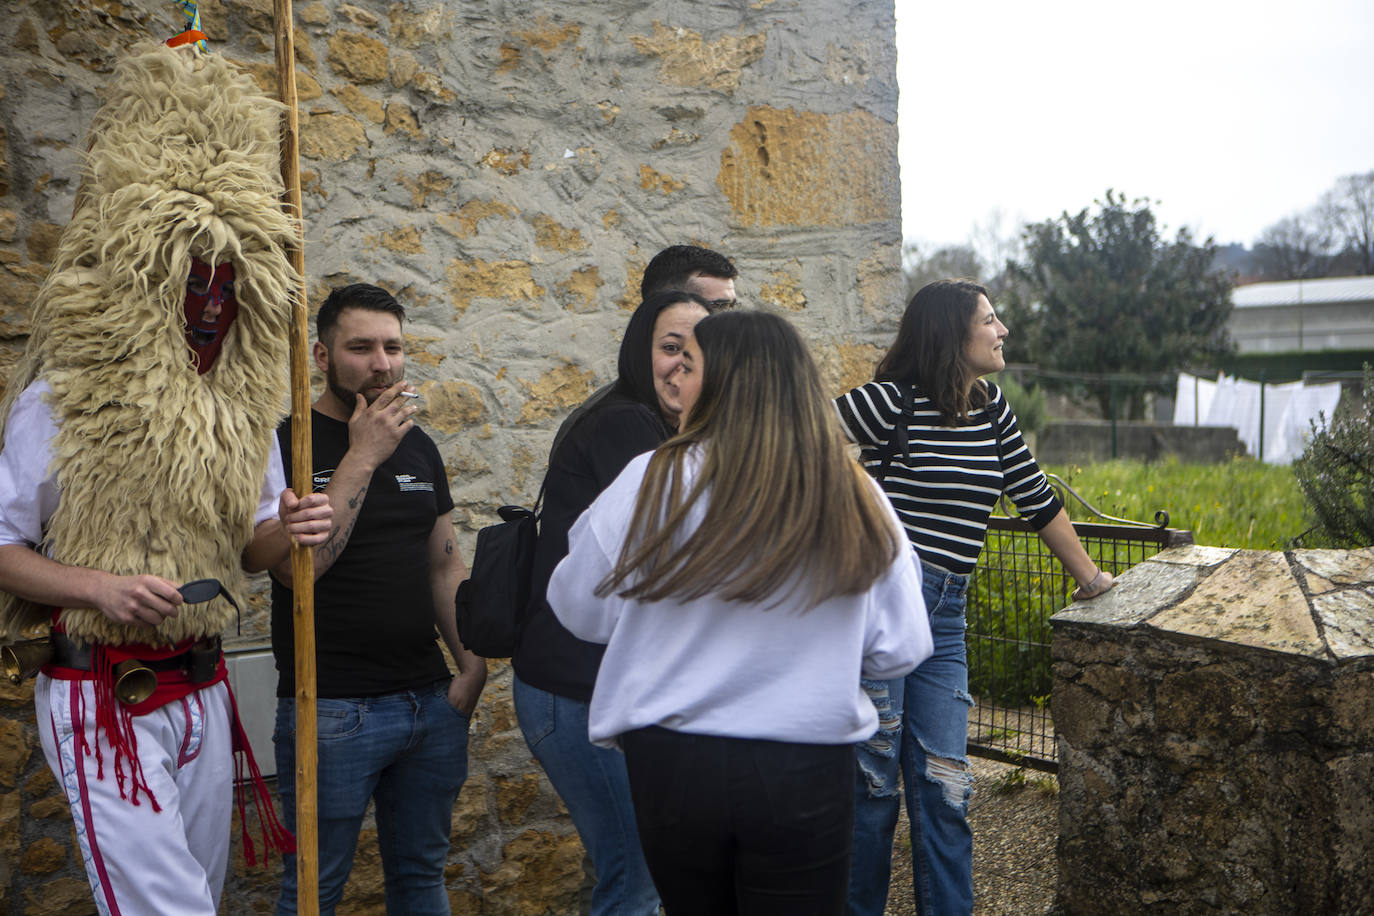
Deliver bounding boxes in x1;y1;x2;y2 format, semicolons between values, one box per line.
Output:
849;563;973;916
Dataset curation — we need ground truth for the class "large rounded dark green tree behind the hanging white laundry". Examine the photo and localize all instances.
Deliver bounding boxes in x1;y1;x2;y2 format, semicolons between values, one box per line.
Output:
1003;190;1232;417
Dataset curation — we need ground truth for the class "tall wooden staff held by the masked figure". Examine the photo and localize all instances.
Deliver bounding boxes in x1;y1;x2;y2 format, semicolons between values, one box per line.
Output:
272;0;320;916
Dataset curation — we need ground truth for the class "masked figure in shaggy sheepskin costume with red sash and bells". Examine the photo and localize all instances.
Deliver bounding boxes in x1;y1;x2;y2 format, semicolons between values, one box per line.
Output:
0;47;331;915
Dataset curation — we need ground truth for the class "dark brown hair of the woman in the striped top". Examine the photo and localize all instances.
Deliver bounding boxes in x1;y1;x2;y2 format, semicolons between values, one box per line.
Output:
874;280;992;426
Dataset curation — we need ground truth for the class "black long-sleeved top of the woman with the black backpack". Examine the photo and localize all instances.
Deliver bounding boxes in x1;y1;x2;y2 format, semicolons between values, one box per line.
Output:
511;393;668;702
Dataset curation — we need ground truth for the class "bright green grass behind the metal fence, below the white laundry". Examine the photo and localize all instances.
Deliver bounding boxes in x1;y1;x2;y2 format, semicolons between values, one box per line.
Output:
1044;459;1331;551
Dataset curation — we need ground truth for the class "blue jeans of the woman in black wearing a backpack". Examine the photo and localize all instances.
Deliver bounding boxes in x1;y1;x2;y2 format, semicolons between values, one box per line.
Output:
513;677;658;916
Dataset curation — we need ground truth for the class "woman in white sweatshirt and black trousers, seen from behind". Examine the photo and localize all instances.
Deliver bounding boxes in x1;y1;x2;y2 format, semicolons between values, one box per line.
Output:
548;312;930;916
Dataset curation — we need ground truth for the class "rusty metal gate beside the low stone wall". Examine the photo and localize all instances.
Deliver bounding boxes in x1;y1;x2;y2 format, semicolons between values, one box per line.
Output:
966;475;1193;772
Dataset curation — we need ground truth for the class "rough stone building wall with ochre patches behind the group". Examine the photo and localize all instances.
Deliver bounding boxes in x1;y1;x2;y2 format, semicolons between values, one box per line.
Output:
0;0;901;913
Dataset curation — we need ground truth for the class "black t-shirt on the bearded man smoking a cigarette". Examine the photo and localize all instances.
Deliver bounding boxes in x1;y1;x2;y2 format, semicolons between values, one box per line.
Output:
272;411;453;698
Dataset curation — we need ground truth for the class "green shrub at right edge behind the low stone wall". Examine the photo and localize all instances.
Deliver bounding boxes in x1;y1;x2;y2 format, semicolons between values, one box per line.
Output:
1293;363;1374;547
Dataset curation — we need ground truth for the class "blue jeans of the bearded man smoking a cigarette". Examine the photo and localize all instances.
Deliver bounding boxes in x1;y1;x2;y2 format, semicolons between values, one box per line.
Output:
272;681;467;916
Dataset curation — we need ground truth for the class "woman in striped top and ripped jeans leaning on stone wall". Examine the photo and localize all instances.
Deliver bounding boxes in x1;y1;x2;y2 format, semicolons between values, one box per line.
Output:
835;280;1113;916
